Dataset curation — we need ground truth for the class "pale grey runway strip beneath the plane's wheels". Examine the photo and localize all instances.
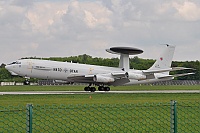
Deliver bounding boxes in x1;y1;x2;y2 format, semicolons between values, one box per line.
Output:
0;90;200;95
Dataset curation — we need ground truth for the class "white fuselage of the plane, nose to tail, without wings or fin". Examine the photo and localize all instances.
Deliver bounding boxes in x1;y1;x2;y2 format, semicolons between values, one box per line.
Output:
6;59;172;85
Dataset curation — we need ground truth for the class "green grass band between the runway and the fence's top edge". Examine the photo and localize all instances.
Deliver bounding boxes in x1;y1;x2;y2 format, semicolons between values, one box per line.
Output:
0;94;200;106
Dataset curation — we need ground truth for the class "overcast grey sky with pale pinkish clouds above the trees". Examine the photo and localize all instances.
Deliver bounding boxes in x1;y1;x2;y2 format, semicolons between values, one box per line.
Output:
0;0;200;63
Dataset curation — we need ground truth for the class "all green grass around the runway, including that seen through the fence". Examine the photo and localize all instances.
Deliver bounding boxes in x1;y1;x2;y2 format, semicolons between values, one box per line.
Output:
0;86;200;132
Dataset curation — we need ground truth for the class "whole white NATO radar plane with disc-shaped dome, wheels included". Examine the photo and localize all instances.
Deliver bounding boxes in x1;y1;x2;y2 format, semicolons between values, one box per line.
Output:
6;44;194;91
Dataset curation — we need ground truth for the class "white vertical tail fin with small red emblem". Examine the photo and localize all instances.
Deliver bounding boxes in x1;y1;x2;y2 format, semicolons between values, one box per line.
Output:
148;44;175;73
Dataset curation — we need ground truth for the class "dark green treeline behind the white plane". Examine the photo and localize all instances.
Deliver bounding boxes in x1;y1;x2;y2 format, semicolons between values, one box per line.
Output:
0;54;200;81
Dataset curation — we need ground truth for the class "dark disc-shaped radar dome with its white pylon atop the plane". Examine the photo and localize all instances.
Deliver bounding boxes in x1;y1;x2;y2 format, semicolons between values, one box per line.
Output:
106;47;143;71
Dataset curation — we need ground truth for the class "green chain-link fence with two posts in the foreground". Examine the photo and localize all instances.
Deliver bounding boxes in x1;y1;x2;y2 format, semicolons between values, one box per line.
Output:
0;101;200;133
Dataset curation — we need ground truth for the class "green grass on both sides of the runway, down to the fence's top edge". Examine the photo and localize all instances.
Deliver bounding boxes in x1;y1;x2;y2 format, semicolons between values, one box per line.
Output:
0;86;200;106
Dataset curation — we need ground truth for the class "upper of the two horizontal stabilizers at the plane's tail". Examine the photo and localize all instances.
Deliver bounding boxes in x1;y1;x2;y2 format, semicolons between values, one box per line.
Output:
142;67;194;75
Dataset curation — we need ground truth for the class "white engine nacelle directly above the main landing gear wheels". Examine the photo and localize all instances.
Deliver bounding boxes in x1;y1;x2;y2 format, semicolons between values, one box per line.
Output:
93;75;115;83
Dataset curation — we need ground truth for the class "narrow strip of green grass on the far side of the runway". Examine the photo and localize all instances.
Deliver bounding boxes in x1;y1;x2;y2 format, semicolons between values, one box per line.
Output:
0;85;200;92
